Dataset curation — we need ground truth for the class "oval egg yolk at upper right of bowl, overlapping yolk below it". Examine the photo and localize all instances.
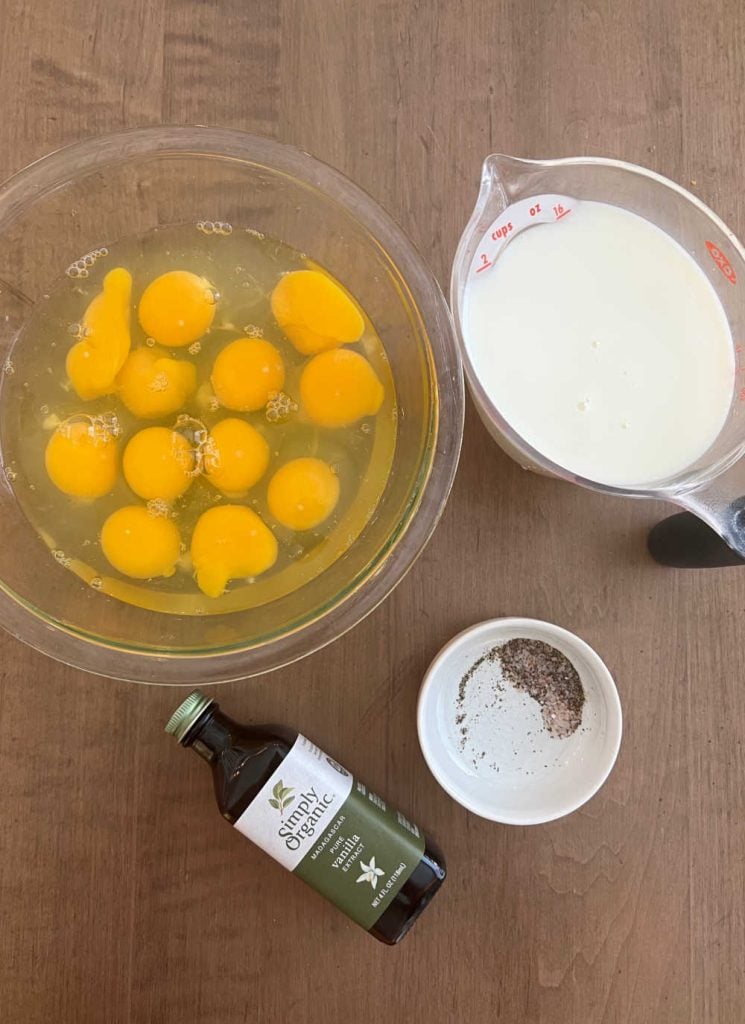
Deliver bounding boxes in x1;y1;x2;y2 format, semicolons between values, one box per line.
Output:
271;270;364;355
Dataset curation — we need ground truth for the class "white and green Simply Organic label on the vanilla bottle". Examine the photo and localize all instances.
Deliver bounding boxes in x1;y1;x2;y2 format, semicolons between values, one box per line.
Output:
235;736;425;929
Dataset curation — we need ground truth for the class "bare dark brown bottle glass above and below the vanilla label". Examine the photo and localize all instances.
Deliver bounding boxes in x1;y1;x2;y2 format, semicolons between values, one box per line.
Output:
181;703;446;945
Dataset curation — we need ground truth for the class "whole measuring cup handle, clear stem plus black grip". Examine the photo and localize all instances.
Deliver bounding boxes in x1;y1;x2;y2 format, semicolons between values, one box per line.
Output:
648;459;745;568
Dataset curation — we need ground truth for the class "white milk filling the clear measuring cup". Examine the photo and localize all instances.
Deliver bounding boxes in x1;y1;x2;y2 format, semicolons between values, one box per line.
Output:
464;202;735;487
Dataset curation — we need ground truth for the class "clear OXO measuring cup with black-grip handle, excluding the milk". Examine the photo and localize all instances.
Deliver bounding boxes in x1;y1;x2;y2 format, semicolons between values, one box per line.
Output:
450;154;745;565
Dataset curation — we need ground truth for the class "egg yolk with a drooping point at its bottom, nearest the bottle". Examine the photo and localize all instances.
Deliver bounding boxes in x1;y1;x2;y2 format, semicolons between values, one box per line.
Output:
191;505;277;597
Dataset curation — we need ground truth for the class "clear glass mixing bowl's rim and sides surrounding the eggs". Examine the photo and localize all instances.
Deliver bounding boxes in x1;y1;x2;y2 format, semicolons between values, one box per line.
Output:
0;127;464;686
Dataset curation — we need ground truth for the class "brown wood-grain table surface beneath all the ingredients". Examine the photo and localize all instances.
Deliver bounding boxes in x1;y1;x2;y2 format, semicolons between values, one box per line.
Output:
0;0;745;1024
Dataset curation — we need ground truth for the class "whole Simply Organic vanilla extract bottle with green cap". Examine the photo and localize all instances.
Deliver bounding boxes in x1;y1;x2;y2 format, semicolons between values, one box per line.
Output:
166;690;445;945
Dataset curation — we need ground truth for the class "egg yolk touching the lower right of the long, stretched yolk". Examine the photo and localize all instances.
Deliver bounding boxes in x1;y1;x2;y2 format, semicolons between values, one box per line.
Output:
117;347;196;420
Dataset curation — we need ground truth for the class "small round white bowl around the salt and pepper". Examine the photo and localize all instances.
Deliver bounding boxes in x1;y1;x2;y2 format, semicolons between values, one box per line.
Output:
417;618;622;825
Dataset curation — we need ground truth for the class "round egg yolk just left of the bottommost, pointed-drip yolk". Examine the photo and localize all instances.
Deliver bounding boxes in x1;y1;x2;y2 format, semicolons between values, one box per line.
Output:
101;505;181;580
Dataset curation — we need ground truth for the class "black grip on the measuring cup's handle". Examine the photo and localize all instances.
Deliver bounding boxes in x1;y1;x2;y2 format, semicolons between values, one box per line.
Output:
647;509;745;569
